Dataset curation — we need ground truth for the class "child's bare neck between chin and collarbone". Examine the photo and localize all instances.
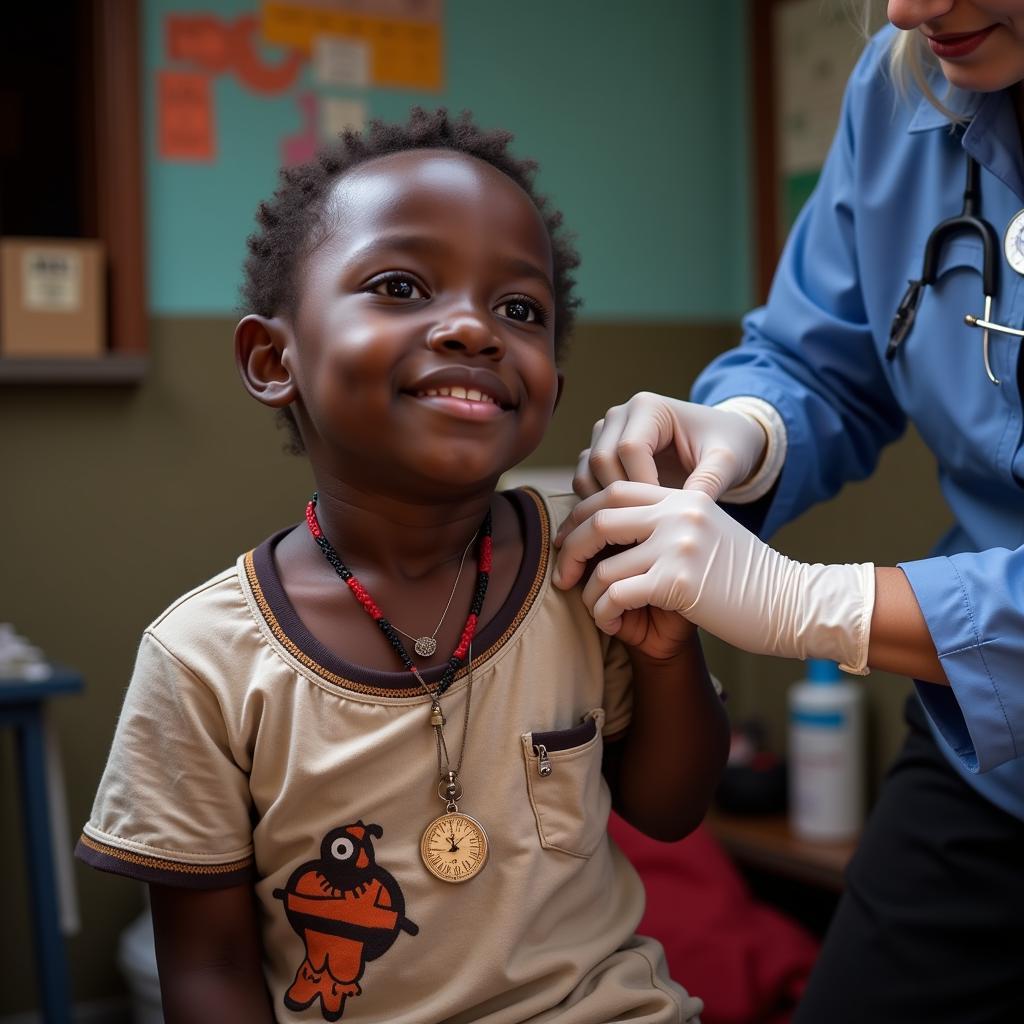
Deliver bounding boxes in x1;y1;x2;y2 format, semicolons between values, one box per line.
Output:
307;481;494;581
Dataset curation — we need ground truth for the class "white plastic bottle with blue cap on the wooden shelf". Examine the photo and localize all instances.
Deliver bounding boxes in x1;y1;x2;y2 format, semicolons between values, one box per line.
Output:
790;658;864;840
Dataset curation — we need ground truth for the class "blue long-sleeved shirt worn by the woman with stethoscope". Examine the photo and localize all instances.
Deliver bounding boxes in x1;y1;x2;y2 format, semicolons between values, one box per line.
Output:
692;29;1024;818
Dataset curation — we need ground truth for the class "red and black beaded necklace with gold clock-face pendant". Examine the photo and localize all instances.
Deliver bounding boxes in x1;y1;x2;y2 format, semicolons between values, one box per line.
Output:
306;493;492;882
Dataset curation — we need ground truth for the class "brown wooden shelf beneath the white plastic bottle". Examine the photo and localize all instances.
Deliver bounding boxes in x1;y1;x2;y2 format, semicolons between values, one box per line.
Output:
708;811;857;891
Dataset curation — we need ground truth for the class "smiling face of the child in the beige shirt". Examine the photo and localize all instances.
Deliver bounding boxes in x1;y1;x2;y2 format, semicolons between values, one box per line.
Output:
286;150;560;492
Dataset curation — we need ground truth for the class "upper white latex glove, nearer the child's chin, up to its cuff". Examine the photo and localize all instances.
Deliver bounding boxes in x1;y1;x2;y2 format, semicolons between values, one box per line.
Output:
572;391;767;499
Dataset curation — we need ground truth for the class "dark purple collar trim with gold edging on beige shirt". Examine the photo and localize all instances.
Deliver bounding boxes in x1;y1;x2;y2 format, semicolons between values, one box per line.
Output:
244;487;551;697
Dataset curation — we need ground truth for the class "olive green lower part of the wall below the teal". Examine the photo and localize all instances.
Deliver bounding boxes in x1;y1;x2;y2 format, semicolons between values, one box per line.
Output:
0;318;943;1014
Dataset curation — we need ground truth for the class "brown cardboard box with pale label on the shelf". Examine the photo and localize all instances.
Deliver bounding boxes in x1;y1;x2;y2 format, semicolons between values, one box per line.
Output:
0;238;106;358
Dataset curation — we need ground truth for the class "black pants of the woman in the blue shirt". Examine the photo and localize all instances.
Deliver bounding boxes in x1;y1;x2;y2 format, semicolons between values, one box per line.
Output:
794;697;1024;1024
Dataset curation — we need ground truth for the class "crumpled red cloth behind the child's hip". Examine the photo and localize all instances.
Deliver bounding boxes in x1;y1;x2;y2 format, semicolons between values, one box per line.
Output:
608;815;818;1024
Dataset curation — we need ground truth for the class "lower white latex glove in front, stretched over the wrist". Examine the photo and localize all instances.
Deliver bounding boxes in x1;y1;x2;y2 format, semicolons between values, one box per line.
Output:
555;482;874;675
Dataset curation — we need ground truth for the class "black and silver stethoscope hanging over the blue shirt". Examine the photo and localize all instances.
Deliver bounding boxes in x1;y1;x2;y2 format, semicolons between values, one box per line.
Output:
886;156;1024;384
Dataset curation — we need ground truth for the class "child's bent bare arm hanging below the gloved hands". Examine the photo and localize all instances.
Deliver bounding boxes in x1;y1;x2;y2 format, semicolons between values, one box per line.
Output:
603;622;729;842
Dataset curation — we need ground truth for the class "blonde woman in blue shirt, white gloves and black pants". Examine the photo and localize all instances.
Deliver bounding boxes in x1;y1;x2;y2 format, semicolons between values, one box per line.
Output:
556;0;1024;1024
